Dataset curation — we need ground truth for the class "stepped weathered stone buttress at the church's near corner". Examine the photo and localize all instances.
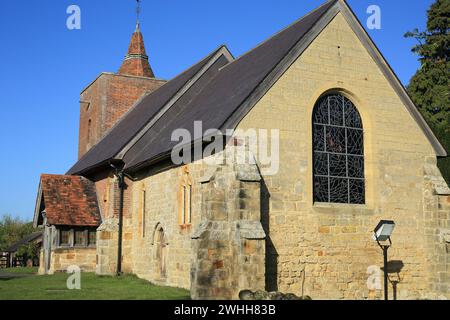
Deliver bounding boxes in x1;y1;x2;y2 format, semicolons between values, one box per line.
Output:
191;155;265;299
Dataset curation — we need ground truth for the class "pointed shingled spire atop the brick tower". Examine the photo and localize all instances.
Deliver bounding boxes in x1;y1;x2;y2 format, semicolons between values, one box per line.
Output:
118;1;155;78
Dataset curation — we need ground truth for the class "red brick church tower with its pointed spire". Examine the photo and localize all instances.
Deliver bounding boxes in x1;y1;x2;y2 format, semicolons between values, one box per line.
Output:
78;2;165;159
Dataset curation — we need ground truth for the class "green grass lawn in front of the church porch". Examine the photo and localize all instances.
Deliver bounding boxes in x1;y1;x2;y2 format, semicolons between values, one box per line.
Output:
0;268;189;300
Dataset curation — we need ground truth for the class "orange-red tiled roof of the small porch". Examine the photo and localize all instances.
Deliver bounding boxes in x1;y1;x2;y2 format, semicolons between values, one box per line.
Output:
37;174;101;226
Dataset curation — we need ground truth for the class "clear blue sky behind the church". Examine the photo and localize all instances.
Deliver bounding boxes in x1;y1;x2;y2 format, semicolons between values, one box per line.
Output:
0;0;433;219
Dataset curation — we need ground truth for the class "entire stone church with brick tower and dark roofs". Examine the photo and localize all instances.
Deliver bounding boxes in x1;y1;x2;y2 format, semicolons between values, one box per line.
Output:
34;0;450;299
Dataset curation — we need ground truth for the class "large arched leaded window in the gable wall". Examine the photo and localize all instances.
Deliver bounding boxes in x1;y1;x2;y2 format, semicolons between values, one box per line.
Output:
313;93;365;204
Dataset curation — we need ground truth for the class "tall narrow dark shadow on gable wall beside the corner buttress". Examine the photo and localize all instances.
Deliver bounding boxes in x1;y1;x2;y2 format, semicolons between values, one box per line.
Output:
260;179;278;291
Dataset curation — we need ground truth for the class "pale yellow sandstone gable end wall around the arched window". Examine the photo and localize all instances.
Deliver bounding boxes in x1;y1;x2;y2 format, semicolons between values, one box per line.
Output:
238;14;449;299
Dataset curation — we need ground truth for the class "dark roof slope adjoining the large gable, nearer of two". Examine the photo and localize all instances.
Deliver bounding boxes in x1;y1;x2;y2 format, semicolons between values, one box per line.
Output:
123;1;336;170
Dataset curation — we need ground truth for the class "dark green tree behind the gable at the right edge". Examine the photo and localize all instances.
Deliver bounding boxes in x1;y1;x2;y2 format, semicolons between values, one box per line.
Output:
405;0;450;184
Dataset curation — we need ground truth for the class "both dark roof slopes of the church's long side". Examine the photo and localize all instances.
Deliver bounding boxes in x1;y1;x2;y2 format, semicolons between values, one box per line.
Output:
68;0;336;174
